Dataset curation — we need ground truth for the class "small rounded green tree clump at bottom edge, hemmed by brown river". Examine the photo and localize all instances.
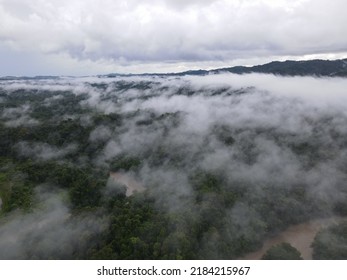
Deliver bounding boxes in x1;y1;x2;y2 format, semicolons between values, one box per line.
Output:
262;242;302;260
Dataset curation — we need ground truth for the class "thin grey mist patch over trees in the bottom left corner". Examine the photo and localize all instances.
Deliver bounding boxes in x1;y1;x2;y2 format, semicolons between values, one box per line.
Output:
0;188;107;259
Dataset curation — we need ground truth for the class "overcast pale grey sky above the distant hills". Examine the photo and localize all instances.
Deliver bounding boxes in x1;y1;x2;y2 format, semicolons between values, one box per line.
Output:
0;0;347;76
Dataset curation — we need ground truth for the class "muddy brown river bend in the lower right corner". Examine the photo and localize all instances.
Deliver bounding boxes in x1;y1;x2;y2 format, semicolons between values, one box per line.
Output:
241;217;347;260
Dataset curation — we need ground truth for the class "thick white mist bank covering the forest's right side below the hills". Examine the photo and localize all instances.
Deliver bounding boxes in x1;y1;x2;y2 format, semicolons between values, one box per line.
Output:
71;74;347;223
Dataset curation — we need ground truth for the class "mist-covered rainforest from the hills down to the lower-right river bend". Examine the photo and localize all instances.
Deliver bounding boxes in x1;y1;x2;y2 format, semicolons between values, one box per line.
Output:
0;73;347;259
